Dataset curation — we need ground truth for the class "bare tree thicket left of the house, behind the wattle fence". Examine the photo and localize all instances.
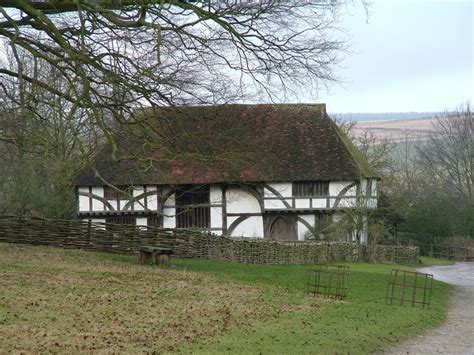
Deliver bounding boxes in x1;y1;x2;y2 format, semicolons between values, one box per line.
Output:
0;49;93;217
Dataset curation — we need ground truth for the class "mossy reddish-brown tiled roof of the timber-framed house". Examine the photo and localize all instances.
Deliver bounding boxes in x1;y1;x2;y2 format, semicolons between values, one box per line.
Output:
76;104;377;185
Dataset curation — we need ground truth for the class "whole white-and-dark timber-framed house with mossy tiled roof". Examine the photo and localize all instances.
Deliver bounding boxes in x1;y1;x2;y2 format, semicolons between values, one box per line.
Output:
76;104;378;242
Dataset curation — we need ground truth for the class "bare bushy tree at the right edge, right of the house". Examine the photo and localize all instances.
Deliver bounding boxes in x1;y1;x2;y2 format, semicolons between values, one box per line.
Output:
388;104;474;242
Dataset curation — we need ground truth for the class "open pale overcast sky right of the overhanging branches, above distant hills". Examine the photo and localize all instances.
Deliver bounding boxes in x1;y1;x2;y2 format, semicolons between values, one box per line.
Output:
318;0;474;112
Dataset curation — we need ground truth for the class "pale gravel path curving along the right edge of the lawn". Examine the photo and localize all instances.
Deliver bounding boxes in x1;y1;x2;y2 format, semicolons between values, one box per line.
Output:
384;263;474;355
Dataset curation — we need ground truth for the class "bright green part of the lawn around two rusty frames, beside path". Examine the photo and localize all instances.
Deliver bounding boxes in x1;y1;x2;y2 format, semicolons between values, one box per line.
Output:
177;260;450;354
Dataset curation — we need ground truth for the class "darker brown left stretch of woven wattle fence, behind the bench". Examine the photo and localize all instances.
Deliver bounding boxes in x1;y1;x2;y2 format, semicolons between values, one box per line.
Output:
0;217;217;258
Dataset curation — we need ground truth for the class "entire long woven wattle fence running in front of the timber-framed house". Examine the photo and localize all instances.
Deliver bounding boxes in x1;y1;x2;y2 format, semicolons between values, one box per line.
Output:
0;216;419;264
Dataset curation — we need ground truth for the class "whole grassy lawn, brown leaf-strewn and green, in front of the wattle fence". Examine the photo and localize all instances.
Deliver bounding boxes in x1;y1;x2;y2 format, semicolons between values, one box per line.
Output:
0;244;450;354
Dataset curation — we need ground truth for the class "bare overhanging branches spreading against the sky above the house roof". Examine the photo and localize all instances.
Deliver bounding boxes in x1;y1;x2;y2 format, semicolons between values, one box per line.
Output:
0;0;352;131
